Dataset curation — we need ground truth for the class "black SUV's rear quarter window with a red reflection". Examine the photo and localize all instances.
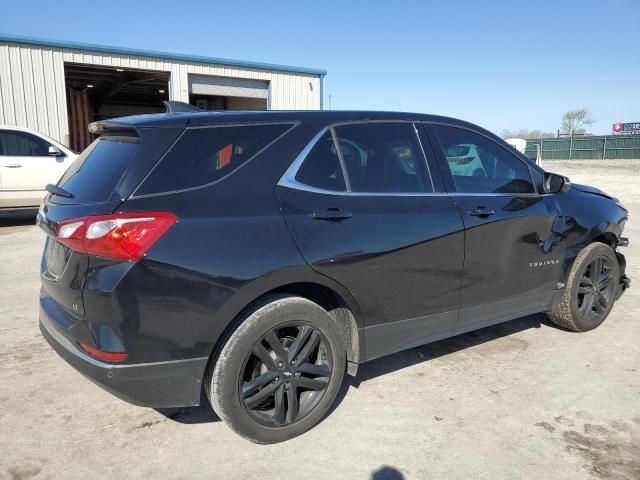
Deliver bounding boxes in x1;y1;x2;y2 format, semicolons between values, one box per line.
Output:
136;124;292;195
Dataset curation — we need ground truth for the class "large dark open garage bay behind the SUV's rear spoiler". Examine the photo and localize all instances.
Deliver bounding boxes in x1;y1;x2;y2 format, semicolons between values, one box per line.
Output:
64;63;169;152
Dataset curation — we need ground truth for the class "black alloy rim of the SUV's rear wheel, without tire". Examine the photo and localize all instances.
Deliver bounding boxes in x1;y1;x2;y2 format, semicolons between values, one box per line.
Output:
239;321;333;428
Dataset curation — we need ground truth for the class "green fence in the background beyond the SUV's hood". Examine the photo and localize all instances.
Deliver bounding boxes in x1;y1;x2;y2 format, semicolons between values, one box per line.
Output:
524;135;640;161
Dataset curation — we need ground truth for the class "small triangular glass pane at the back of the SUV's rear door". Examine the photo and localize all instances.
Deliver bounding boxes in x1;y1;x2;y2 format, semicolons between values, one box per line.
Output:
296;130;346;192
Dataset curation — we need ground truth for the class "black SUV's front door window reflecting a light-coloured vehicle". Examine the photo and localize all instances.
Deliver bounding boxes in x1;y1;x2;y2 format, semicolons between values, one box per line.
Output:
434;125;535;193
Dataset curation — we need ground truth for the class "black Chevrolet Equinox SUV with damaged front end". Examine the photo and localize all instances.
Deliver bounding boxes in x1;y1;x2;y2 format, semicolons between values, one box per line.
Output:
38;106;628;443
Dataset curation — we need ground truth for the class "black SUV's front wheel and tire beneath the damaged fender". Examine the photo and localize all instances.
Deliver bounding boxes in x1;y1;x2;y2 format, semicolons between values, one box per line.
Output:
549;242;620;332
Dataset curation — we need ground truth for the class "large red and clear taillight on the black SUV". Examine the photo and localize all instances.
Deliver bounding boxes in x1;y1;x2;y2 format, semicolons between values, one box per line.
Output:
56;212;178;262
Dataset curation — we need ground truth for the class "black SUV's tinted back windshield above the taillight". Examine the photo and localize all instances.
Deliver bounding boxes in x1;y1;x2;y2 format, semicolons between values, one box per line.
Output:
58;136;140;203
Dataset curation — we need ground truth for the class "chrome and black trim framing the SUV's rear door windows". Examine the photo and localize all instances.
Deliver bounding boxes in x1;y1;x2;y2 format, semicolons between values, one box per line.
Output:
277;120;443;197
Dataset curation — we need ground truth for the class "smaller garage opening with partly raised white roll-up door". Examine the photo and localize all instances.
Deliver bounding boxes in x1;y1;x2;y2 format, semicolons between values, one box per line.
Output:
189;75;269;110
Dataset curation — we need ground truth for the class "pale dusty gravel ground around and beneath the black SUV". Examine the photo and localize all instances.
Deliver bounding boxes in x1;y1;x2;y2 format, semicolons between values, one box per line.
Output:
0;161;640;480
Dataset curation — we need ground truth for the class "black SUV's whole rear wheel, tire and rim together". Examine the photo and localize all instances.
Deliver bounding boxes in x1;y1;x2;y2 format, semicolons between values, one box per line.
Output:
205;295;346;444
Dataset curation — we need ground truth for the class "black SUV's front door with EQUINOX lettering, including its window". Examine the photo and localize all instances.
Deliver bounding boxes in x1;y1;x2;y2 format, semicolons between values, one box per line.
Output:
427;125;567;330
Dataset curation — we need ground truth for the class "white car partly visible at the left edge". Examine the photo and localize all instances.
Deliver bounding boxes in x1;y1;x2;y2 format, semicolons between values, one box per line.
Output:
0;125;78;215
